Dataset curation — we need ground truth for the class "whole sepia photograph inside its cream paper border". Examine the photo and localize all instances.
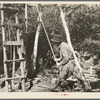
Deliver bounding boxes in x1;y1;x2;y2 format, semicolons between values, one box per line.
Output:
0;2;100;95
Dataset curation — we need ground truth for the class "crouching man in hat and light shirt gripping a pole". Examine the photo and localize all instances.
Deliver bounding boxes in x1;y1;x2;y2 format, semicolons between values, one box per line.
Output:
51;34;91;90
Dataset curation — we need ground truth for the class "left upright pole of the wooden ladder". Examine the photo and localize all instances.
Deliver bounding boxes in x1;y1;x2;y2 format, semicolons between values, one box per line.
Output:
1;4;8;92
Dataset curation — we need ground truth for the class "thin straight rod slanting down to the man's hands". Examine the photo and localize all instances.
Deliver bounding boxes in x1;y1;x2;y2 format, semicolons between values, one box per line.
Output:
36;5;56;58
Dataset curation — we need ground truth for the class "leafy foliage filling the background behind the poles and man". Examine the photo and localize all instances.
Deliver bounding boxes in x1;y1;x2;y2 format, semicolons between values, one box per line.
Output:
0;4;100;73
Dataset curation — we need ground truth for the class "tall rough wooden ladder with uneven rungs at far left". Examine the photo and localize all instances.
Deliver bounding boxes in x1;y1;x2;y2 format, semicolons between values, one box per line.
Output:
1;4;25;92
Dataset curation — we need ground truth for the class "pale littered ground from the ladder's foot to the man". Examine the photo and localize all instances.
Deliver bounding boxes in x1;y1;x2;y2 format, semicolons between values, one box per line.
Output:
0;70;53;92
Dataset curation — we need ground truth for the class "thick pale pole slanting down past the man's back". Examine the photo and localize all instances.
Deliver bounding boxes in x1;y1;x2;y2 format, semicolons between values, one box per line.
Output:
58;5;82;72
